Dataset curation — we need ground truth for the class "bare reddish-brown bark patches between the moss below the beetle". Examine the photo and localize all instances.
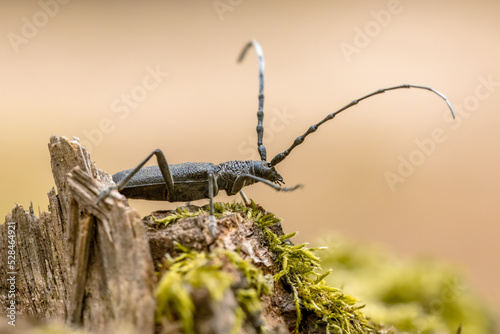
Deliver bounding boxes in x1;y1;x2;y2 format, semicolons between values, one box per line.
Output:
143;205;296;334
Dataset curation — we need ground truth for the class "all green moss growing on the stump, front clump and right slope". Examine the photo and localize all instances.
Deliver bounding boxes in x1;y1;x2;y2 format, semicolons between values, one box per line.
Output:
152;201;377;333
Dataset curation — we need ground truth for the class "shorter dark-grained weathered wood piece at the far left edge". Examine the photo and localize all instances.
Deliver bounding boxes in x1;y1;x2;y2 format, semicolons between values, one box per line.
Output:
0;201;68;321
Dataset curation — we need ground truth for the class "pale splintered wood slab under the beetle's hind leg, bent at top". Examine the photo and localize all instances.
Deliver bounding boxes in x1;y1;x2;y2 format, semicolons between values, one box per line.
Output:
68;168;155;333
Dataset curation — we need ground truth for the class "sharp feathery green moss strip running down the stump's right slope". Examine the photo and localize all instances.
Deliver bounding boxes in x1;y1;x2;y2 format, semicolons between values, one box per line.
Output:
240;201;377;333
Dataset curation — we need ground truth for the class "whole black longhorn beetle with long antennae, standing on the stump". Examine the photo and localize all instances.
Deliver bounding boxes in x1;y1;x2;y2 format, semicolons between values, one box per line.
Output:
98;41;455;237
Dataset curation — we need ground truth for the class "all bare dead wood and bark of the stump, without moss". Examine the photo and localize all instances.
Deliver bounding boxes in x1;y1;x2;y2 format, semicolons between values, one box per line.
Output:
0;136;342;334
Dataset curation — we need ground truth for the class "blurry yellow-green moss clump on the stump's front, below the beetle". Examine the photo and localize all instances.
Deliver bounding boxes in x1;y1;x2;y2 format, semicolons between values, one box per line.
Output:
156;245;271;334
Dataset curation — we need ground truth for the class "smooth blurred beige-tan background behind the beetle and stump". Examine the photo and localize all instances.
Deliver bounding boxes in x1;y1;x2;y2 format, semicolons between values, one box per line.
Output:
0;0;500;324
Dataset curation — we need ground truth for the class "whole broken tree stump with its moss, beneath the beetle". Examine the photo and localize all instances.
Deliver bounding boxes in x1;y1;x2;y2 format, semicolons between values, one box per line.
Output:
0;136;382;334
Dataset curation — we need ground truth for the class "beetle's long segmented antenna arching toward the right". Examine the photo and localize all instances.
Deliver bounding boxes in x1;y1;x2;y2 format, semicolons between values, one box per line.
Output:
271;84;455;166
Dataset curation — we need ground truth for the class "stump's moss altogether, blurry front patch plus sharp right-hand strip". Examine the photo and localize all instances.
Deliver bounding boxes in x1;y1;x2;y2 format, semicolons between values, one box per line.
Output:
157;201;379;333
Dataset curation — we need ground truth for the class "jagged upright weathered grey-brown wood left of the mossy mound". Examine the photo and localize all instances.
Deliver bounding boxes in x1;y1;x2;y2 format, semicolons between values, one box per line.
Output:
0;136;155;333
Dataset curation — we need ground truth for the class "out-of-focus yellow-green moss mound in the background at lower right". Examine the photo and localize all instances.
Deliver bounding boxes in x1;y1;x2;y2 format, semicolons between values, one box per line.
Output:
318;238;495;334
